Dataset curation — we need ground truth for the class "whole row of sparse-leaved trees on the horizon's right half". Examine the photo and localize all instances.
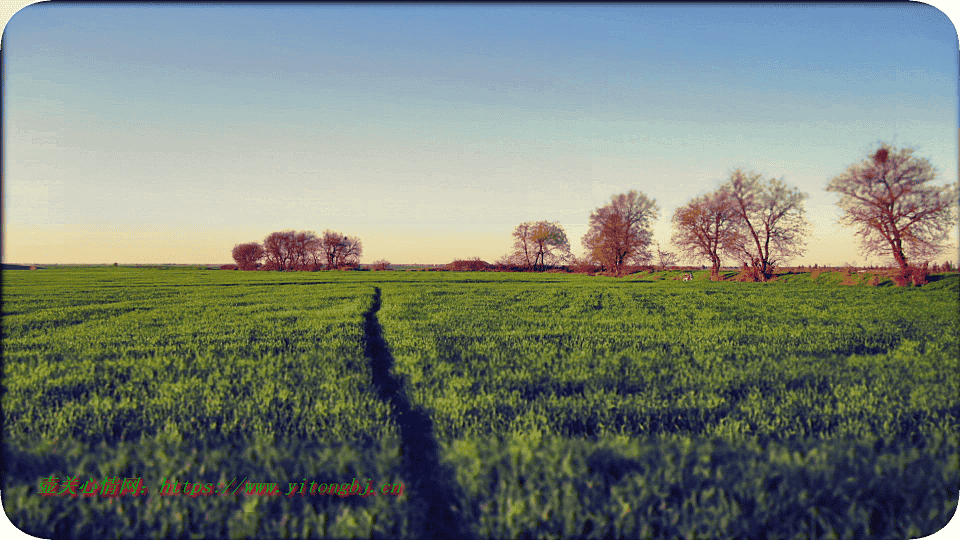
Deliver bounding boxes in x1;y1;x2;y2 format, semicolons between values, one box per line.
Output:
499;143;958;281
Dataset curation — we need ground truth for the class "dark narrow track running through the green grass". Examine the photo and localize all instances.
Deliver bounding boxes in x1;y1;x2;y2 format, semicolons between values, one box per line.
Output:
363;287;470;539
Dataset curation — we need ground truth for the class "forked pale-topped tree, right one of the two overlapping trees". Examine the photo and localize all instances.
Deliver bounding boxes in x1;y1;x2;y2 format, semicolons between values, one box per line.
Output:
721;169;808;281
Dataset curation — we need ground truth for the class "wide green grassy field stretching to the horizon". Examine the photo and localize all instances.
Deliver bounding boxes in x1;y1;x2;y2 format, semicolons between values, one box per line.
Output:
2;268;960;538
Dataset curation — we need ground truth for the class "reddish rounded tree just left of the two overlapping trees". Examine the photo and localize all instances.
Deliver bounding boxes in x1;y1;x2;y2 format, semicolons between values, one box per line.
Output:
583;190;660;276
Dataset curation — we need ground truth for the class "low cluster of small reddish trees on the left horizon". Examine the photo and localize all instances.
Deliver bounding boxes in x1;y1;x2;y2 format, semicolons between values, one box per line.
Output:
233;230;363;270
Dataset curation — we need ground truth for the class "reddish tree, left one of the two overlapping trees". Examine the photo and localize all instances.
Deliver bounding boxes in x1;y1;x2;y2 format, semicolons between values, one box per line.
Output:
672;190;739;281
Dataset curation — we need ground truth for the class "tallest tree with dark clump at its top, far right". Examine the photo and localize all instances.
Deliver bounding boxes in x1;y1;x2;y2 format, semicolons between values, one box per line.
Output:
827;143;957;272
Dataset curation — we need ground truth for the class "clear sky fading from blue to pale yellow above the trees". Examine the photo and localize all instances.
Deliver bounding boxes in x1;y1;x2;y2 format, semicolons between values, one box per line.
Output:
2;3;960;265
